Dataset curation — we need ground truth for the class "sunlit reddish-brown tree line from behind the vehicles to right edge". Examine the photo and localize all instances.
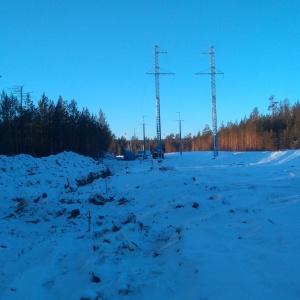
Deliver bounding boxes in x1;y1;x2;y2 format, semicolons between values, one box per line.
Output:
109;98;300;154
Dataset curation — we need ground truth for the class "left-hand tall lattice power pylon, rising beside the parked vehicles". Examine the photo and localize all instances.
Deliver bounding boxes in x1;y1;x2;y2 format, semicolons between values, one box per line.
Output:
146;45;175;159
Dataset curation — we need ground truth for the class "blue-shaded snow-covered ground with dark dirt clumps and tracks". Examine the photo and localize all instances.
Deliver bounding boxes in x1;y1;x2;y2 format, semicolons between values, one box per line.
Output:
0;150;300;300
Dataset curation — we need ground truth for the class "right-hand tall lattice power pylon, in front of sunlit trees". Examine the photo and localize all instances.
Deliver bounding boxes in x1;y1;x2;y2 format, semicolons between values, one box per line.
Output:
196;46;224;157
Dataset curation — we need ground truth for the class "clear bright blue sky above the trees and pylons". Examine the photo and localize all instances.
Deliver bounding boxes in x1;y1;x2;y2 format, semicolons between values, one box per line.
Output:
0;0;300;138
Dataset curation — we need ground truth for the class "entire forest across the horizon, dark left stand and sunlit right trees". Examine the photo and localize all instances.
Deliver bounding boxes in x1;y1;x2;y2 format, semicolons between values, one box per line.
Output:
0;91;300;158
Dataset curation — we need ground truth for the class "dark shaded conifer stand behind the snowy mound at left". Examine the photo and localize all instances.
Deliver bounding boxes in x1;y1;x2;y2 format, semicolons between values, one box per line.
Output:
0;91;113;158
